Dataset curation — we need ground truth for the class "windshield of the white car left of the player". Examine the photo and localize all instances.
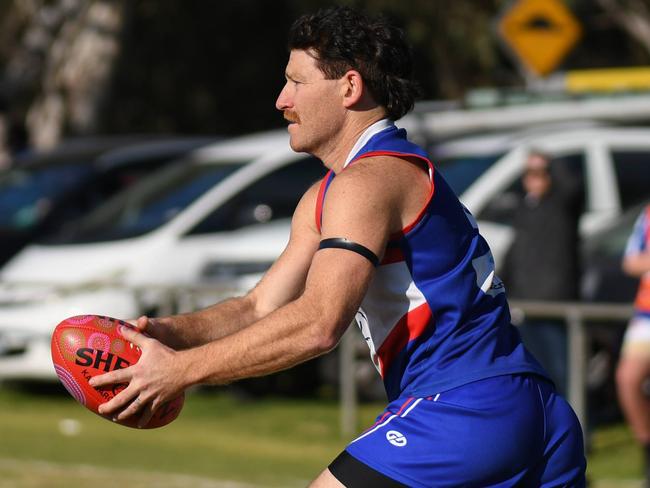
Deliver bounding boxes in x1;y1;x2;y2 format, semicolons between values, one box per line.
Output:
46;163;242;244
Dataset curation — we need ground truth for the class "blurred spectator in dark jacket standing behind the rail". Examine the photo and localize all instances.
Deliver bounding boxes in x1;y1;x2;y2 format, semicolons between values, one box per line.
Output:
502;151;582;393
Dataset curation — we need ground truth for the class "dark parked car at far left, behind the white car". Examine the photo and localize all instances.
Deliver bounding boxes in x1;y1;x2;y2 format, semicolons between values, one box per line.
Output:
0;136;217;266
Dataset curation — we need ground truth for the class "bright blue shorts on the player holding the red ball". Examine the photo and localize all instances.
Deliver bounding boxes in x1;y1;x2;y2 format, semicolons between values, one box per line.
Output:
329;374;586;488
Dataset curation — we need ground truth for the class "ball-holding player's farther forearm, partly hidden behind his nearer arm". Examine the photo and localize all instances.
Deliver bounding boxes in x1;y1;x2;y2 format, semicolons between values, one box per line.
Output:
147;295;260;350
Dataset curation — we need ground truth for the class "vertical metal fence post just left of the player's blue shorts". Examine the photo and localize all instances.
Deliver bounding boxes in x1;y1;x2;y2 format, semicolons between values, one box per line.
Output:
339;324;357;437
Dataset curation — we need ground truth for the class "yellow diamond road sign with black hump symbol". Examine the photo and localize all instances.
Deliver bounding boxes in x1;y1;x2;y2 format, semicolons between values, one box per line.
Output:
498;0;581;76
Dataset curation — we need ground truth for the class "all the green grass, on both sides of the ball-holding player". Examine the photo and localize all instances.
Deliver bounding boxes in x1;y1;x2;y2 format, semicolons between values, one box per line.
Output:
0;389;641;488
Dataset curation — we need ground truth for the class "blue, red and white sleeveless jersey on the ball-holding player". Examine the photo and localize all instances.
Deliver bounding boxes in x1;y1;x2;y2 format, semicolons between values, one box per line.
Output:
316;125;546;400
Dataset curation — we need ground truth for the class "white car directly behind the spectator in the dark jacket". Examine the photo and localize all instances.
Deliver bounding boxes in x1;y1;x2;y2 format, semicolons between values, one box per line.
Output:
432;126;650;268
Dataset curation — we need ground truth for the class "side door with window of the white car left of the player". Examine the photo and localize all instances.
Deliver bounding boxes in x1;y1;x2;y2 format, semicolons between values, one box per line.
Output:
162;157;326;283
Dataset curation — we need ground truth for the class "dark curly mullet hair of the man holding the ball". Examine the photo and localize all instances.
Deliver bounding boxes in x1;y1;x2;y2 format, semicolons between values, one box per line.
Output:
289;7;418;120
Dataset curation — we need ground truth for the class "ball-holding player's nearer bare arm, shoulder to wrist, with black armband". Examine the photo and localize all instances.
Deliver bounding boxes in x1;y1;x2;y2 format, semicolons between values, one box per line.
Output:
161;156;422;383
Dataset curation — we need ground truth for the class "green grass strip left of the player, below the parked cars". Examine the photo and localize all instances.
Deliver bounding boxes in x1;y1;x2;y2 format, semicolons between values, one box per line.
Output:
0;390;380;486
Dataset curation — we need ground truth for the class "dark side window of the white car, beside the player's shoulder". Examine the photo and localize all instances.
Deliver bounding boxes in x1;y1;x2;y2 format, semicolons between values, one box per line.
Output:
189;157;326;234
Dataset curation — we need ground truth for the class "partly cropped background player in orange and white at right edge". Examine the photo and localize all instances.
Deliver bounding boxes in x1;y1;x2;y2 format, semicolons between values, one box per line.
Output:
616;206;650;486
